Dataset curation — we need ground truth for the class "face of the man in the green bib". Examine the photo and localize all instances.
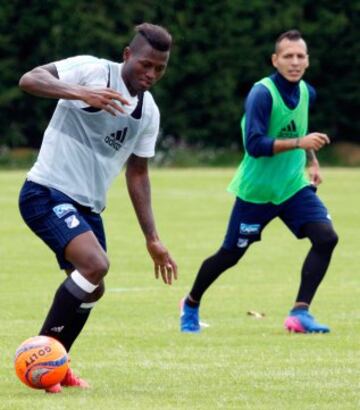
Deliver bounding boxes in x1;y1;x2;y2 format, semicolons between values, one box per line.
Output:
272;38;309;82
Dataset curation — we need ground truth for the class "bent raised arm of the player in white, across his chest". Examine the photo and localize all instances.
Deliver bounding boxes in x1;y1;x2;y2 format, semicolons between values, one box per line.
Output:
19;63;129;115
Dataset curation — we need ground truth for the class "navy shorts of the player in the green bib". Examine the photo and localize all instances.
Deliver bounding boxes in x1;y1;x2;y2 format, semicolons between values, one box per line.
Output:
222;185;331;249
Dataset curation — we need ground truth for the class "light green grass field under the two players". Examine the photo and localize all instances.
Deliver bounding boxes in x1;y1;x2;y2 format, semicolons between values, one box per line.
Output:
0;169;360;410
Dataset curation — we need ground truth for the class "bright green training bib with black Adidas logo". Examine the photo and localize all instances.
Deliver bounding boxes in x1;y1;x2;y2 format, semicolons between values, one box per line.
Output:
228;77;309;205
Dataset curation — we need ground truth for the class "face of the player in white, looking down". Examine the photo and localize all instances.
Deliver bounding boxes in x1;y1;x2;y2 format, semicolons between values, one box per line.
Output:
122;43;170;95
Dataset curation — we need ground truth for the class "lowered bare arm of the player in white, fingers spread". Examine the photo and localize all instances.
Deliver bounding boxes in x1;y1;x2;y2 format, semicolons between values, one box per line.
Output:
126;155;177;285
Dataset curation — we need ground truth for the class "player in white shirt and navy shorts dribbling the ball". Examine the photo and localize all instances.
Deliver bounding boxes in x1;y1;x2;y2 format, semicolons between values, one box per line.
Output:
19;23;177;393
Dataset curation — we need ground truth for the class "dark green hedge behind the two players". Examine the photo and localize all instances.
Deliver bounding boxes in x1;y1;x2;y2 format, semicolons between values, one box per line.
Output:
0;0;360;151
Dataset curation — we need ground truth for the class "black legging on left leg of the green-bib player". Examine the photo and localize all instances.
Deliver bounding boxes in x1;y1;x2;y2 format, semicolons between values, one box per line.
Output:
187;248;247;306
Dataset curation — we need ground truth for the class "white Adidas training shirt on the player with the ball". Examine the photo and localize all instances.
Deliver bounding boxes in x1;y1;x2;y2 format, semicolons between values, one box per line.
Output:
28;56;160;213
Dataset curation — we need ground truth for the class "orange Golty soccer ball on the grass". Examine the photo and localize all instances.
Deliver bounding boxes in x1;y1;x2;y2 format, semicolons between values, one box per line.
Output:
14;336;68;389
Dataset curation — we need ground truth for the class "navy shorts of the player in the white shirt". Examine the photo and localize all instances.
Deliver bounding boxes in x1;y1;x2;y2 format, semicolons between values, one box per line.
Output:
19;181;106;269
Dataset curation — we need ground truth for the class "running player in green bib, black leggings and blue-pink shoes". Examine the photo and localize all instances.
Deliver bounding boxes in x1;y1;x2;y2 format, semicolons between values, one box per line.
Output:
180;30;338;333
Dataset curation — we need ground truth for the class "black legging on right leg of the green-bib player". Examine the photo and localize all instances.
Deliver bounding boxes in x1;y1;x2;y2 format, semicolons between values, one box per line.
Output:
296;223;338;305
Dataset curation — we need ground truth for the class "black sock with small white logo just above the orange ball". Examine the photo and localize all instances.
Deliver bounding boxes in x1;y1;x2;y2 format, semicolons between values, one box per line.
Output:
40;277;90;351
